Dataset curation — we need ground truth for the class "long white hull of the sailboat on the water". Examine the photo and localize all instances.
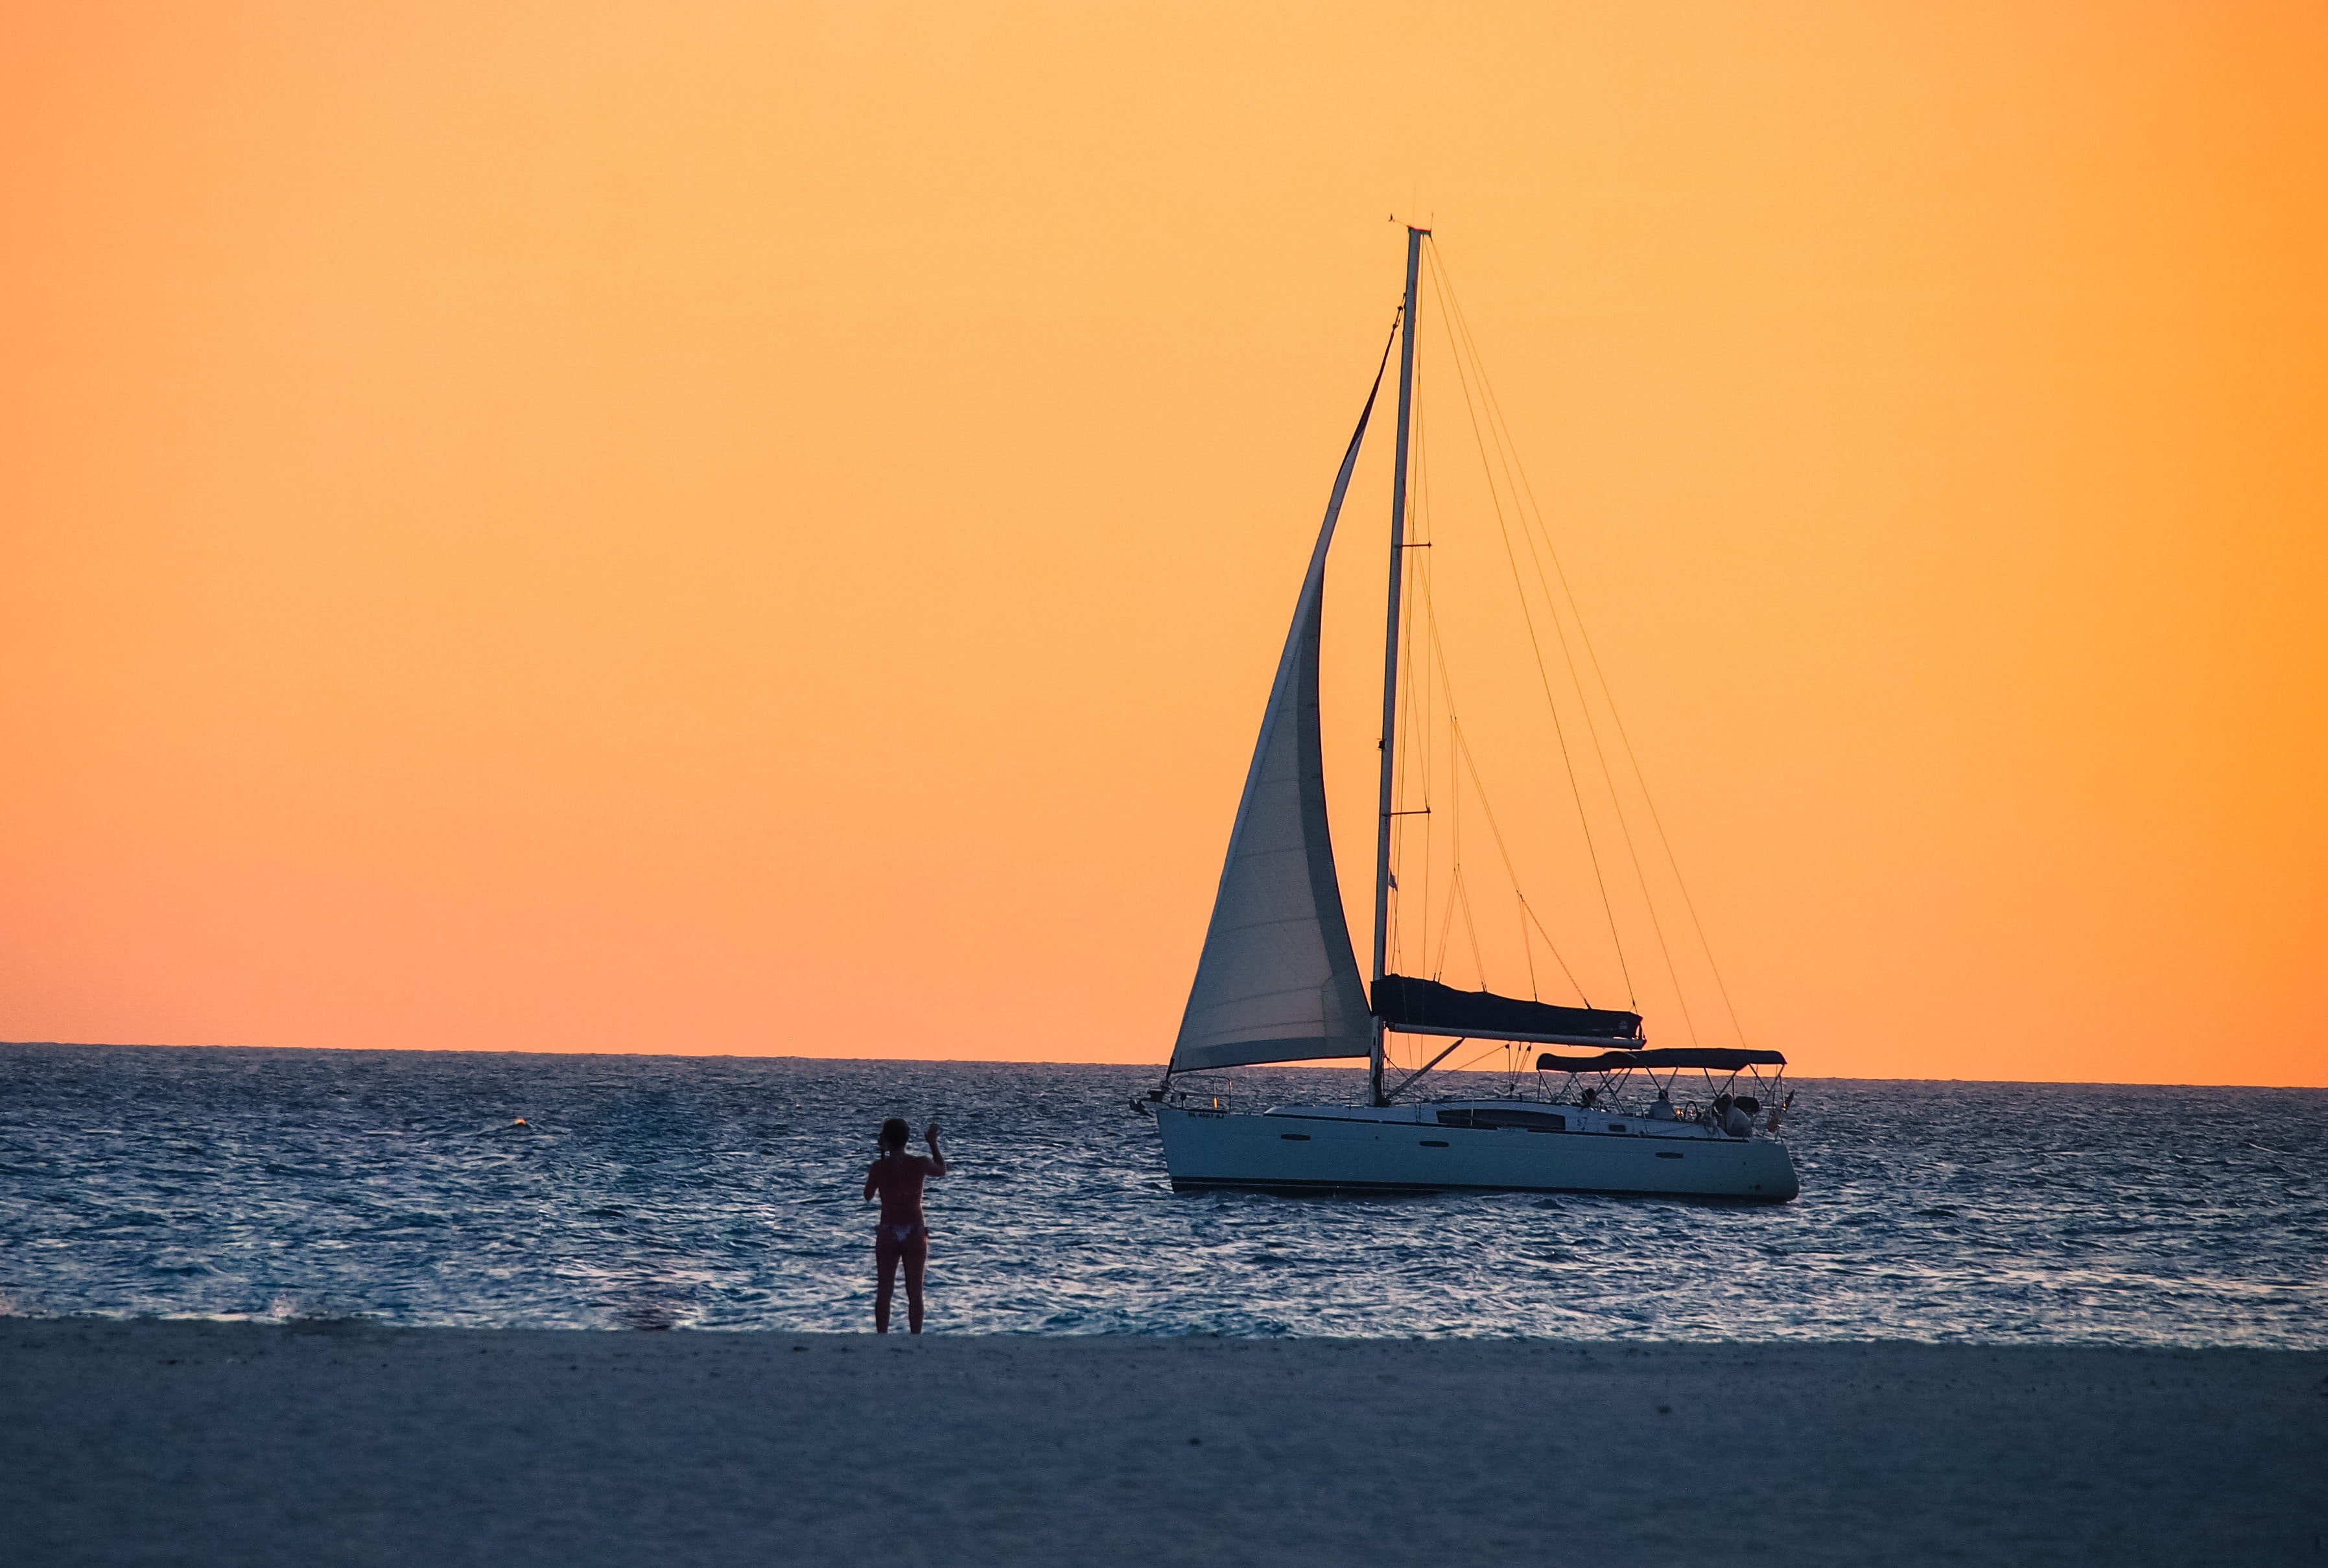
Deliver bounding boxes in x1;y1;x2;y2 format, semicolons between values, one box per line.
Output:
1155;1105;1802;1203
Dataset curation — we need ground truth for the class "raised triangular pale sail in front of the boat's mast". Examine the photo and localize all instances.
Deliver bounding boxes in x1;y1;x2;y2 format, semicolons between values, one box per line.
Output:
1171;356;1387;1073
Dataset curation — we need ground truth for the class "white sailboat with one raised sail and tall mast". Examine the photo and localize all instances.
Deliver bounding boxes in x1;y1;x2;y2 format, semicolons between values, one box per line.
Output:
1134;226;1800;1203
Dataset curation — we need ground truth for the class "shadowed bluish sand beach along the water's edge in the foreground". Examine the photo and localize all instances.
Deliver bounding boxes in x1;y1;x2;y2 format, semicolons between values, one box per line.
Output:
0;1319;2328;1565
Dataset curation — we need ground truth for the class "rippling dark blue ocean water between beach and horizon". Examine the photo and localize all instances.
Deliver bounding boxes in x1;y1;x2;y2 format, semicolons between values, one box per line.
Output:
0;1044;2328;1347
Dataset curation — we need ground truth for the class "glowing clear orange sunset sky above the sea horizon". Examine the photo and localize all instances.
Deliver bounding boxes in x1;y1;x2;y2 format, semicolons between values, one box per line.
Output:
0;0;2328;1084
